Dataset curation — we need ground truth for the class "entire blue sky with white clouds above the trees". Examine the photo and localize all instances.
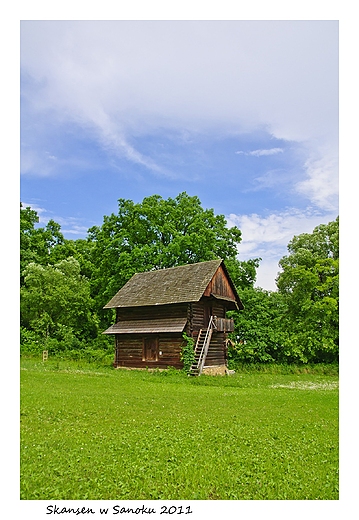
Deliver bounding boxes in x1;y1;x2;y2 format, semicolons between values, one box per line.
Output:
21;21;339;290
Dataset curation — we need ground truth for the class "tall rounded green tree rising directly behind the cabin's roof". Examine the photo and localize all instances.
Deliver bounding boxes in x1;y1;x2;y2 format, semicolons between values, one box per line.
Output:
89;192;241;320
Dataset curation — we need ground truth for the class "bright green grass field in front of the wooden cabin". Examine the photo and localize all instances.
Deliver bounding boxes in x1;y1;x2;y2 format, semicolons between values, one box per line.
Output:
21;360;339;500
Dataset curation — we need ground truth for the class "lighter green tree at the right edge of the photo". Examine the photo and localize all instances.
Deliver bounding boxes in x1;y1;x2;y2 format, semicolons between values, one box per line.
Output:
277;217;339;362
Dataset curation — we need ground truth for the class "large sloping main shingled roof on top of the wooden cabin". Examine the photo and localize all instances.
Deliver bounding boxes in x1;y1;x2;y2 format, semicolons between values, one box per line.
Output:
104;259;238;309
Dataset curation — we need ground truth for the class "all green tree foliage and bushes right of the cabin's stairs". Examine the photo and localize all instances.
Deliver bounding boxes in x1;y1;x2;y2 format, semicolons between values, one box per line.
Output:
229;219;339;363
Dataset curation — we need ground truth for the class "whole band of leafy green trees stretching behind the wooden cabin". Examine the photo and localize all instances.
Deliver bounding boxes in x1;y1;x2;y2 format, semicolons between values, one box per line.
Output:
20;192;339;365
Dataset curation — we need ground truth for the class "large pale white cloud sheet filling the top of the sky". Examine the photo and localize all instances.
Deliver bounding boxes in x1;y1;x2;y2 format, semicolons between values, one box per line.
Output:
21;21;338;181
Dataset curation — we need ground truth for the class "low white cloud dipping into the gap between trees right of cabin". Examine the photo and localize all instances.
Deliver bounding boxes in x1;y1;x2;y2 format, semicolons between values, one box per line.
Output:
227;209;337;290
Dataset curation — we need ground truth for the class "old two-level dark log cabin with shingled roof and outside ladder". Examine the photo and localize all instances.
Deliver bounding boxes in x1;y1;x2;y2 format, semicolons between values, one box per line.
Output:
104;260;243;375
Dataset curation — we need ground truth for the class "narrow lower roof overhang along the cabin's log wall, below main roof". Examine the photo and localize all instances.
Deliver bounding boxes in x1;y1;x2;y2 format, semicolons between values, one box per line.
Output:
102;318;187;334
